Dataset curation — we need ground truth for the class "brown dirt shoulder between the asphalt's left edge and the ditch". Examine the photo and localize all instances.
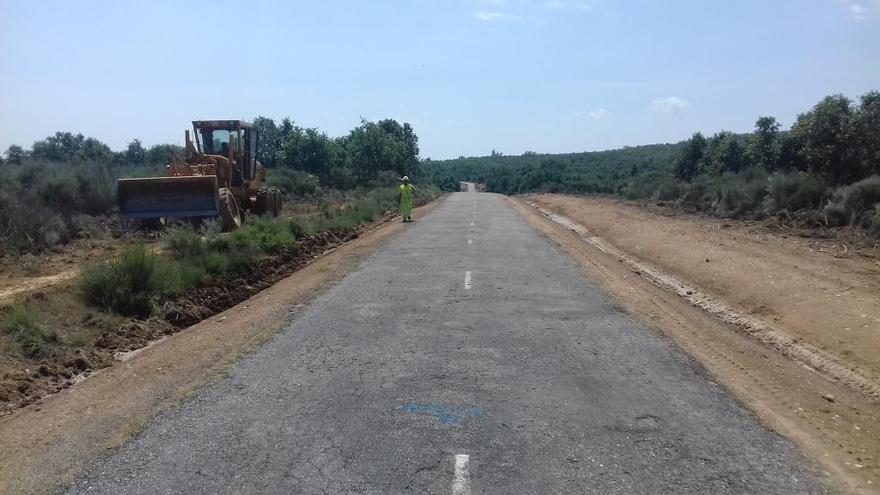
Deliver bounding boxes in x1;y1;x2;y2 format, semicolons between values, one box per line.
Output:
0;201;441;493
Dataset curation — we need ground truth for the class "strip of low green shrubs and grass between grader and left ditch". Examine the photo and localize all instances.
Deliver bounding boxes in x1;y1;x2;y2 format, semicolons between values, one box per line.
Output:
78;186;439;318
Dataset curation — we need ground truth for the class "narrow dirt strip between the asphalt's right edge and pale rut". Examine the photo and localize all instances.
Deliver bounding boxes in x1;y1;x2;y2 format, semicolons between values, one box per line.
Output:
506;197;877;494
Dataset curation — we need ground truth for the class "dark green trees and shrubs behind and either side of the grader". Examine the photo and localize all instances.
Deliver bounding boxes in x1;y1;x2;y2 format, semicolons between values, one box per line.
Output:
0;117;419;252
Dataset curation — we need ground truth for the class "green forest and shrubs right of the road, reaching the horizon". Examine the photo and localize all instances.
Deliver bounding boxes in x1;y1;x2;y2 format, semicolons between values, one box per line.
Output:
420;91;880;236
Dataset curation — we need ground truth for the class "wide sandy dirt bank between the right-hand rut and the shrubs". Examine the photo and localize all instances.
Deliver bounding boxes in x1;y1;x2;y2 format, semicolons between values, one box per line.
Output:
529;194;880;381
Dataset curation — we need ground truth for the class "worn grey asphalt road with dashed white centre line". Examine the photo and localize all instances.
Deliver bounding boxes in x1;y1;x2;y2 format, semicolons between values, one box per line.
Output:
69;193;825;494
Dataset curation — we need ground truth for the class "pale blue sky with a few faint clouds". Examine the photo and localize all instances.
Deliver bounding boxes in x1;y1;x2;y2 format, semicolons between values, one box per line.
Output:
0;0;880;159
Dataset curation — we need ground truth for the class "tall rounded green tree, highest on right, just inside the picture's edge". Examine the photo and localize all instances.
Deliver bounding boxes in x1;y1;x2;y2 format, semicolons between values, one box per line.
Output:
791;95;862;184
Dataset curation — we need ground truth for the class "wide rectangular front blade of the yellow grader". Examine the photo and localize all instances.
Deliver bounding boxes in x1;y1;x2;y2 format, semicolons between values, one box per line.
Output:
116;175;220;218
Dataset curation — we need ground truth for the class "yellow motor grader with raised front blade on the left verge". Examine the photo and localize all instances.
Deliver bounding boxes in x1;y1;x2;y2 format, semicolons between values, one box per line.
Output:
116;120;282;232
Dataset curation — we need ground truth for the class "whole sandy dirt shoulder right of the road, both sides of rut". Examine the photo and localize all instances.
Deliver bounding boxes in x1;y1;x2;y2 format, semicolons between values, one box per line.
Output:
511;195;880;493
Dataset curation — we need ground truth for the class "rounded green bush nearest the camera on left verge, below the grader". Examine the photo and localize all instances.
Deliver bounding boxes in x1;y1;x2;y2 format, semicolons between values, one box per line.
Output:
79;244;180;318
